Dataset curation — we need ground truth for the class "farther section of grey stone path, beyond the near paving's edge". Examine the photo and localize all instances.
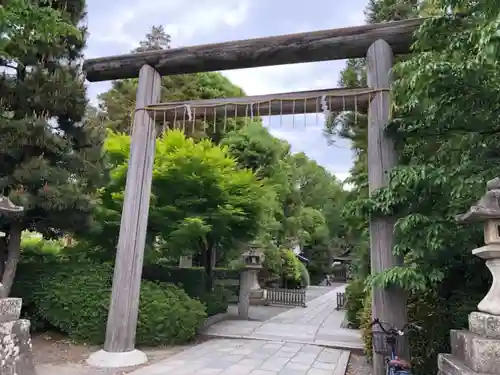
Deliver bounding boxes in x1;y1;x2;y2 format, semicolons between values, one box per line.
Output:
204;285;363;349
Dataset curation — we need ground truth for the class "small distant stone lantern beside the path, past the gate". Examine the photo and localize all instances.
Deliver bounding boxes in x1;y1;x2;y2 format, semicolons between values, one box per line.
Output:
238;245;266;319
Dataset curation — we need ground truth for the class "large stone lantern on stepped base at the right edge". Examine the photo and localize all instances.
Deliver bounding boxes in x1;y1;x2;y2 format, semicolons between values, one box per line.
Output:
438;178;500;375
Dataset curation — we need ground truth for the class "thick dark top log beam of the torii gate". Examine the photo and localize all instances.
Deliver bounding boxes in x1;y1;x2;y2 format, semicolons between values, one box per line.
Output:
83;18;423;82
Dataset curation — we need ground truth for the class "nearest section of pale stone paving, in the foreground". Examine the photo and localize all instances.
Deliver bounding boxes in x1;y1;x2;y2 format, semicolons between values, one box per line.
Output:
129;339;350;375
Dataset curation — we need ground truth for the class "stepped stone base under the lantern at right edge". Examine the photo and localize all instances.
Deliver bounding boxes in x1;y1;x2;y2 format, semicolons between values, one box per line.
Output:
438;312;500;375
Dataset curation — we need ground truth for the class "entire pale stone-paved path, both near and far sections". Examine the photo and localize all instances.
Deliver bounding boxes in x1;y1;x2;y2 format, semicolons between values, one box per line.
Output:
125;288;355;375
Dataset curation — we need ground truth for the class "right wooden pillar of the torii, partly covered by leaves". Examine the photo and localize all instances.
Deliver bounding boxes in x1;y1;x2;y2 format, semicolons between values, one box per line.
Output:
366;39;408;375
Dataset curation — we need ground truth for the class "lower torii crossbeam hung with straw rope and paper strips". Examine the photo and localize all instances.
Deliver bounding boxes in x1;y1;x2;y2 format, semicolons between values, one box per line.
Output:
147;88;376;122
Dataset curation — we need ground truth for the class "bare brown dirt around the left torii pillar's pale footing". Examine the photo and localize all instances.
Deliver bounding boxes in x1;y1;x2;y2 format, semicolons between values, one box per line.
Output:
32;332;206;375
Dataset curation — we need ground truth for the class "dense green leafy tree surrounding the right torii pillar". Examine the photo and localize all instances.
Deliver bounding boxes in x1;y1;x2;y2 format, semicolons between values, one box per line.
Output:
328;0;500;374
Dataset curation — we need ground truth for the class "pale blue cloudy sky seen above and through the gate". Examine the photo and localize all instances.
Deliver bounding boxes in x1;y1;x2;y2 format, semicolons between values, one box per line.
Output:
86;0;367;180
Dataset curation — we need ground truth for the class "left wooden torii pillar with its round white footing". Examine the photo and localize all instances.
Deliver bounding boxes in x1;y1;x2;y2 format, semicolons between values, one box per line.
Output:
87;65;161;367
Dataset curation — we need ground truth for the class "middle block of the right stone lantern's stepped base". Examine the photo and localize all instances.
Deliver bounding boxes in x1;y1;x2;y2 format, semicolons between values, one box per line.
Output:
450;330;500;375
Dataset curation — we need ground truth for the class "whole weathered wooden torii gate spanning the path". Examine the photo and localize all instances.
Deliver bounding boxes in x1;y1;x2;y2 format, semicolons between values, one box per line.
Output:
83;19;423;375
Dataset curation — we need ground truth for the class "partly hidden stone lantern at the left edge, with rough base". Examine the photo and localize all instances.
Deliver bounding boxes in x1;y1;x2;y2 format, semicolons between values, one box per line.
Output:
0;197;36;375
